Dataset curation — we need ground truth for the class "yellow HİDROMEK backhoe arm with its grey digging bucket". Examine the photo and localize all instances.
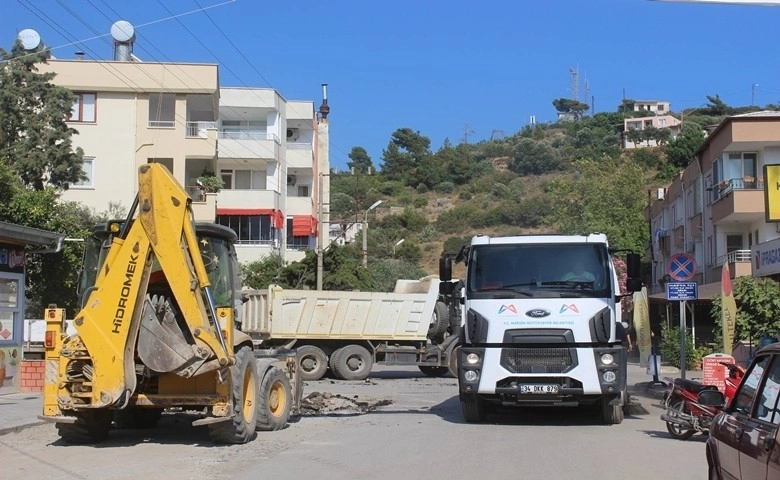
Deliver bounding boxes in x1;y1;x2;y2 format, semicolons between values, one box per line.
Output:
58;163;235;408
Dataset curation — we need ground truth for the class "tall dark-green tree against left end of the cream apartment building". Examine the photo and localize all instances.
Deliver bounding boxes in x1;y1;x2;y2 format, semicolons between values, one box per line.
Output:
0;42;86;190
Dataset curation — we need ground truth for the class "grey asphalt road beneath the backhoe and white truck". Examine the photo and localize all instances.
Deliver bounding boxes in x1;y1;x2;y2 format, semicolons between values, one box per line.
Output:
0;367;707;480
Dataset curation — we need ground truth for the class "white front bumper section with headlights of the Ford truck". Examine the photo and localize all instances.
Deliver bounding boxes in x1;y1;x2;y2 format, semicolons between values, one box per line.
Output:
458;346;626;406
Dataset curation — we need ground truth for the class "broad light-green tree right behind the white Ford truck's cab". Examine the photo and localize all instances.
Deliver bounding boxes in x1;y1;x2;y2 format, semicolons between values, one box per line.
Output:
546;158;647;252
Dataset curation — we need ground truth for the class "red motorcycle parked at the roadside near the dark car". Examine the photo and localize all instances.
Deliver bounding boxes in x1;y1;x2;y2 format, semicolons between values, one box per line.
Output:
661;362;745;440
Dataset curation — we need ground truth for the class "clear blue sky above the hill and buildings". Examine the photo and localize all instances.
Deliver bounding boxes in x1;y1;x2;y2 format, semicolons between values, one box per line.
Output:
0;0;780;169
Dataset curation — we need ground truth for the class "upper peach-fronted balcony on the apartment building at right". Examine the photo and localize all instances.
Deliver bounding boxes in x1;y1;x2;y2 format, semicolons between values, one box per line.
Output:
712;177;764;225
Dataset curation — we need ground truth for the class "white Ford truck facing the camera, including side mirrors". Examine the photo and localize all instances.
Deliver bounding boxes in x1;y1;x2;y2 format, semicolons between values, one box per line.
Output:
440;234;641;424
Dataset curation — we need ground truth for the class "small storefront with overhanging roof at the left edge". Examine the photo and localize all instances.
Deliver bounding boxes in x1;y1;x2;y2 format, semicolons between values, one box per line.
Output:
0;222;64;395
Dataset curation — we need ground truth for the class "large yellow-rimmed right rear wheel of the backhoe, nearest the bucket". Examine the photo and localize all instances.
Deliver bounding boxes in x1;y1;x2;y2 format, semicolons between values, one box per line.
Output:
209;347;260;443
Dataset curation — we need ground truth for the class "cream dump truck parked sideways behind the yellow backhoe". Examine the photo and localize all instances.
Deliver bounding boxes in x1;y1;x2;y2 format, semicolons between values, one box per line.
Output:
241;276;460;380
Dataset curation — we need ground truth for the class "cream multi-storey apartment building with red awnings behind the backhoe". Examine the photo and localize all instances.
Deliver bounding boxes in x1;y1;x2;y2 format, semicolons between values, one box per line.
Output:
32;29;329;262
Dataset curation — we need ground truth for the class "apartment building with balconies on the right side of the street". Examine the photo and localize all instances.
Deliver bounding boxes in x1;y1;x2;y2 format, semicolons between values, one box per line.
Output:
646;111;780;339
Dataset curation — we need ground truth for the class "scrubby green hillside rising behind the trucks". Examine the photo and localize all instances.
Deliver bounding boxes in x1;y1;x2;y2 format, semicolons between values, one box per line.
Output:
245;96;778;290
